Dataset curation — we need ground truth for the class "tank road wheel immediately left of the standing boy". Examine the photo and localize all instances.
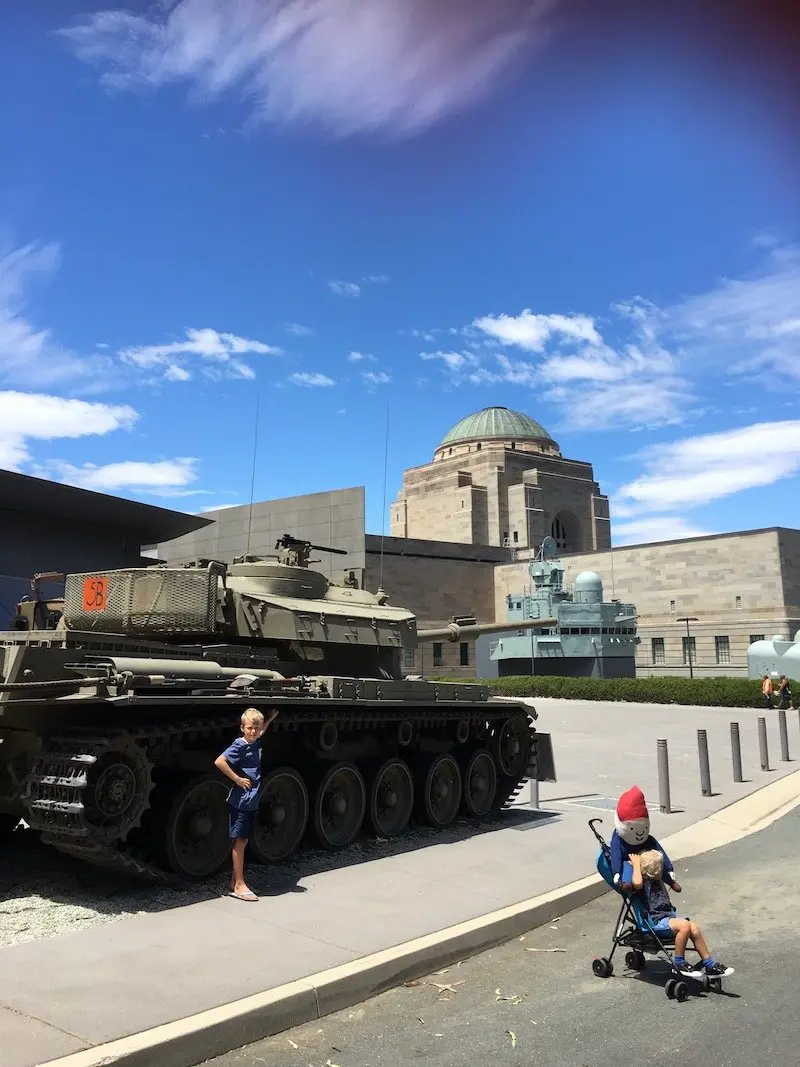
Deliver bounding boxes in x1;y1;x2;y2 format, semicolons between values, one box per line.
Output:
164;774;230;878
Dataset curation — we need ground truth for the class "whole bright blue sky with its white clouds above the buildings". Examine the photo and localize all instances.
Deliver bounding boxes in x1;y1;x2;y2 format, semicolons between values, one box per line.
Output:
0;0;800;544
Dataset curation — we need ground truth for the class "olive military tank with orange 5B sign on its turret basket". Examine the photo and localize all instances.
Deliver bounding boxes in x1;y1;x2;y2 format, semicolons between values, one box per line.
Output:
0;535;551;881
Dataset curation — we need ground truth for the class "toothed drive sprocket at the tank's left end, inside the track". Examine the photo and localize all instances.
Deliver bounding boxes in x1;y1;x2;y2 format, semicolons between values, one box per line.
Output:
82;737;153;843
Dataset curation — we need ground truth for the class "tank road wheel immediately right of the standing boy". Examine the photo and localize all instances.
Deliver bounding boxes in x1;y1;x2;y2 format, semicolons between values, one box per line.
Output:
249;767;308;863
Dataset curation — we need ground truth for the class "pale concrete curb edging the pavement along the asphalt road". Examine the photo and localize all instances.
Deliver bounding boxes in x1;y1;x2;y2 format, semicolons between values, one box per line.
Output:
39;770;800;1067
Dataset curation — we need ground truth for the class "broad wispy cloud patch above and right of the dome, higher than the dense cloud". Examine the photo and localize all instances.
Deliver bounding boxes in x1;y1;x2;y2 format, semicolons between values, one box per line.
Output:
420;245;800;430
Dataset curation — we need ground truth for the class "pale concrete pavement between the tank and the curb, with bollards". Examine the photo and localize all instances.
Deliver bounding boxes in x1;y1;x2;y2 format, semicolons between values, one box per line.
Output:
0;700;800;1067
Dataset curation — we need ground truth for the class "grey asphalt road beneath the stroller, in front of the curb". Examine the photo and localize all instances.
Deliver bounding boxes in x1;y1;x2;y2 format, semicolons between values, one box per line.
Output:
201;808;800;1067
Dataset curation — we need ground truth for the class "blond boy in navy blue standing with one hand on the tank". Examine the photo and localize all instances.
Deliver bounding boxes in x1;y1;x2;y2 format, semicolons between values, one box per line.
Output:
214;707;277;901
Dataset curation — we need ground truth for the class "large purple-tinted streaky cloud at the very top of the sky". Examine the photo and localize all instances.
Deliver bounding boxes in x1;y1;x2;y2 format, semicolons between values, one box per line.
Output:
62;0;555;136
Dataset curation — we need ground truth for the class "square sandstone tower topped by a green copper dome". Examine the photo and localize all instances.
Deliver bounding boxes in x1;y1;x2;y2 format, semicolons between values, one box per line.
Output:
391;408;611;552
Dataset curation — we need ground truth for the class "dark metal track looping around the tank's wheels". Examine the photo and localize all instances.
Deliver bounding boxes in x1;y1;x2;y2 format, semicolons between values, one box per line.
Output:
23;705;535;885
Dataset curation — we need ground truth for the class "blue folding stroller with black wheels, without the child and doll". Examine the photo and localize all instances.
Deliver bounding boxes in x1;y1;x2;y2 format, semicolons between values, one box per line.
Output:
589;818;722;1001
